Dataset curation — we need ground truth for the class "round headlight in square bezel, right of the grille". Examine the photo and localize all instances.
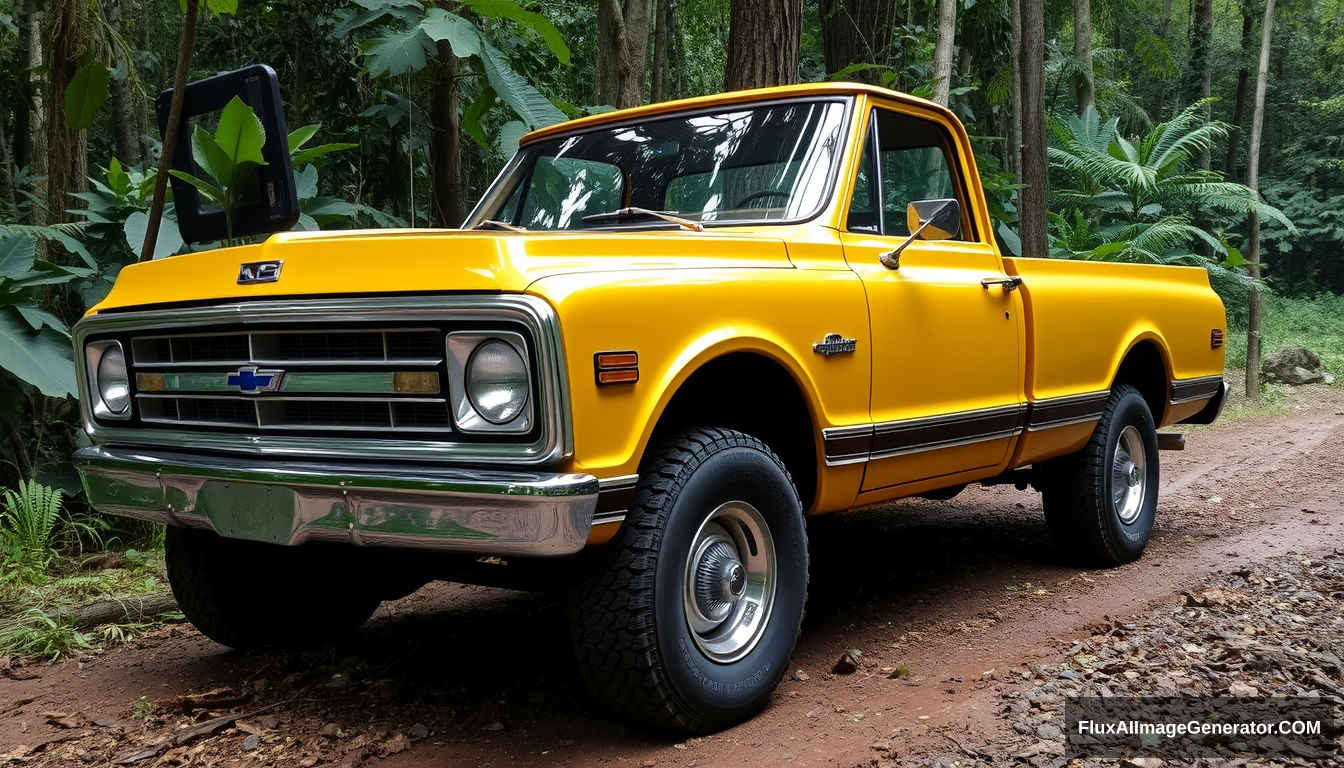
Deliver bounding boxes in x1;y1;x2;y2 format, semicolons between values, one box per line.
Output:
448;331;532;434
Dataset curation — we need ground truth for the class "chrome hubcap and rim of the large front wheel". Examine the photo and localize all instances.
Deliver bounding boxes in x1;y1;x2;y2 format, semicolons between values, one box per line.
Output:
683;502;775;663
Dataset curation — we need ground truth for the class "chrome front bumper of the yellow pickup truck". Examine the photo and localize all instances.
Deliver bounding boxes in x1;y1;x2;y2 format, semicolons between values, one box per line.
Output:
75;445;598;557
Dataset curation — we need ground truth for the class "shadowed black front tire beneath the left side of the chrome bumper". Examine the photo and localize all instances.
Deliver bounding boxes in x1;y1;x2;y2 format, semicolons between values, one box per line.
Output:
164;527;379;651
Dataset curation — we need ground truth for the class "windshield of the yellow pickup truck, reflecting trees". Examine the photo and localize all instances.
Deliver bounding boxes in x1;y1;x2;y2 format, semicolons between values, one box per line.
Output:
468;100;845;230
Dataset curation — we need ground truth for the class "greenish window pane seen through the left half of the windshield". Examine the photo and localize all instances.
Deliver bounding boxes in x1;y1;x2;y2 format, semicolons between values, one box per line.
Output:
505;157;625;229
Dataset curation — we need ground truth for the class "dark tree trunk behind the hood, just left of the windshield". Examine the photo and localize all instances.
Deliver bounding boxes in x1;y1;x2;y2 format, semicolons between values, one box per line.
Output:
429;50;466;227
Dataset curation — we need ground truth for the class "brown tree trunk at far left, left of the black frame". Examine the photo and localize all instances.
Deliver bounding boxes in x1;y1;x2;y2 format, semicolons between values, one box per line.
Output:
46;0;91;223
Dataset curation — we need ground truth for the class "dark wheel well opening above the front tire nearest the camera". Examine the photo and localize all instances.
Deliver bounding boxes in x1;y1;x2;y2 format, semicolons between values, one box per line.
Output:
653;352;817;510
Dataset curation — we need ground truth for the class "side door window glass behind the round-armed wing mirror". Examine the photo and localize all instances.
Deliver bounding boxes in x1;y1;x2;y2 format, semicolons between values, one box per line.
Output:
847;109;972;239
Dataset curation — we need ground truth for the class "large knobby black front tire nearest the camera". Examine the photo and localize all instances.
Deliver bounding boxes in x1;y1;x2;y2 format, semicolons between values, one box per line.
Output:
570;429;808;733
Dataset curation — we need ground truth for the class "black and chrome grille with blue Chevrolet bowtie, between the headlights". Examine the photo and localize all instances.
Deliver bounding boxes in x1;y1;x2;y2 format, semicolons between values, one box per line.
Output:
122;328;452;437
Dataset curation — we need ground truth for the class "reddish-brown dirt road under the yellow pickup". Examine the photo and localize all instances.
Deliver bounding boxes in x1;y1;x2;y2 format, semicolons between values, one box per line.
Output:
0;390;1344;768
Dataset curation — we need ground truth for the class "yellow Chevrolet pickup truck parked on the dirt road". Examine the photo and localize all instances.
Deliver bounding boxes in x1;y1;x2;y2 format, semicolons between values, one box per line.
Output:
75;83;1227;732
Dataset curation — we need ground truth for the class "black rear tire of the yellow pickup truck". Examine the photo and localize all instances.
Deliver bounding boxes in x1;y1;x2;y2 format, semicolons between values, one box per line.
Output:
1039;385;1159;568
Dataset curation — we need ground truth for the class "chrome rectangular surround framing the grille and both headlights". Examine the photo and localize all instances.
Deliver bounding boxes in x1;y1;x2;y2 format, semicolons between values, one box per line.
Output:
74;295;574;467
